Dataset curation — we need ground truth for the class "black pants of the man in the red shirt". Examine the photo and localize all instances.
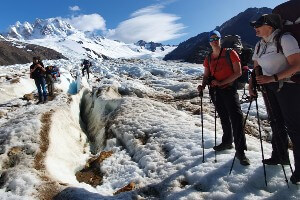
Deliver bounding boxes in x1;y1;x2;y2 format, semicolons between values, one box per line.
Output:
209;87;247;152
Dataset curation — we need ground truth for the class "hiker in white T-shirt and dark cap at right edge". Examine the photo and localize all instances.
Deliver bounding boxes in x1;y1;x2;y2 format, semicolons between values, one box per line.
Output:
249;14;300;184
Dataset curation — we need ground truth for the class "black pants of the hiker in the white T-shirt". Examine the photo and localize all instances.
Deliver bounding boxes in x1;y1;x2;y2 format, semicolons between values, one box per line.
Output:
266;83;300;178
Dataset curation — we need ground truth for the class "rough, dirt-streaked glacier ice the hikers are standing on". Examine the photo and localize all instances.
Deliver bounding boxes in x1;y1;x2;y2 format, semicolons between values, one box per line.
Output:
0;55;300;200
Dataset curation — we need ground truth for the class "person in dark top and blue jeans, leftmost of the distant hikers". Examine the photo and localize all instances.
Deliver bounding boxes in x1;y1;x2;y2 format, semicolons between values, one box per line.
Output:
30;57;47;104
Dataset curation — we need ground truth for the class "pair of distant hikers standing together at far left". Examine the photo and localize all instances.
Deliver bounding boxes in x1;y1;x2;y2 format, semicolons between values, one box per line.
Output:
30;57;60;104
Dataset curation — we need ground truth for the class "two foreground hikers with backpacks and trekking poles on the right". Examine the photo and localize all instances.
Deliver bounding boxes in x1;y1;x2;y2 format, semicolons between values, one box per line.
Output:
198;0;300;185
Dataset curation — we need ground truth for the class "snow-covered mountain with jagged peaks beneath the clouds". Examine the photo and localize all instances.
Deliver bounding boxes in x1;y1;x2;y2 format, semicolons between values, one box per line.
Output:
3;18;176;60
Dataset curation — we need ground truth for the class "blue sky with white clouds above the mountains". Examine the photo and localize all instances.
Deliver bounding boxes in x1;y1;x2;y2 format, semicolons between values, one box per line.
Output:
0;0;286;44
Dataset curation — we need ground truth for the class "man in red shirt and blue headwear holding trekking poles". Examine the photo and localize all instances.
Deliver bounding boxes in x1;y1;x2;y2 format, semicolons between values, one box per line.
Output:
198;30;250;165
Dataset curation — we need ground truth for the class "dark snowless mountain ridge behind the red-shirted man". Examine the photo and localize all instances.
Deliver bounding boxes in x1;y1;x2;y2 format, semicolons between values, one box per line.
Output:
164;7;272;63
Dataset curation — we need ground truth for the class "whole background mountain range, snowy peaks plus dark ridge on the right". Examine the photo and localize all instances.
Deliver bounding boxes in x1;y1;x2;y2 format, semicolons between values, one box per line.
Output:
0;8;272;65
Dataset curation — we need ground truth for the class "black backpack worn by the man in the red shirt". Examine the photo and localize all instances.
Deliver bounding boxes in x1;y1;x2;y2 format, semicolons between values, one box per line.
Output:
208;35;253;90
